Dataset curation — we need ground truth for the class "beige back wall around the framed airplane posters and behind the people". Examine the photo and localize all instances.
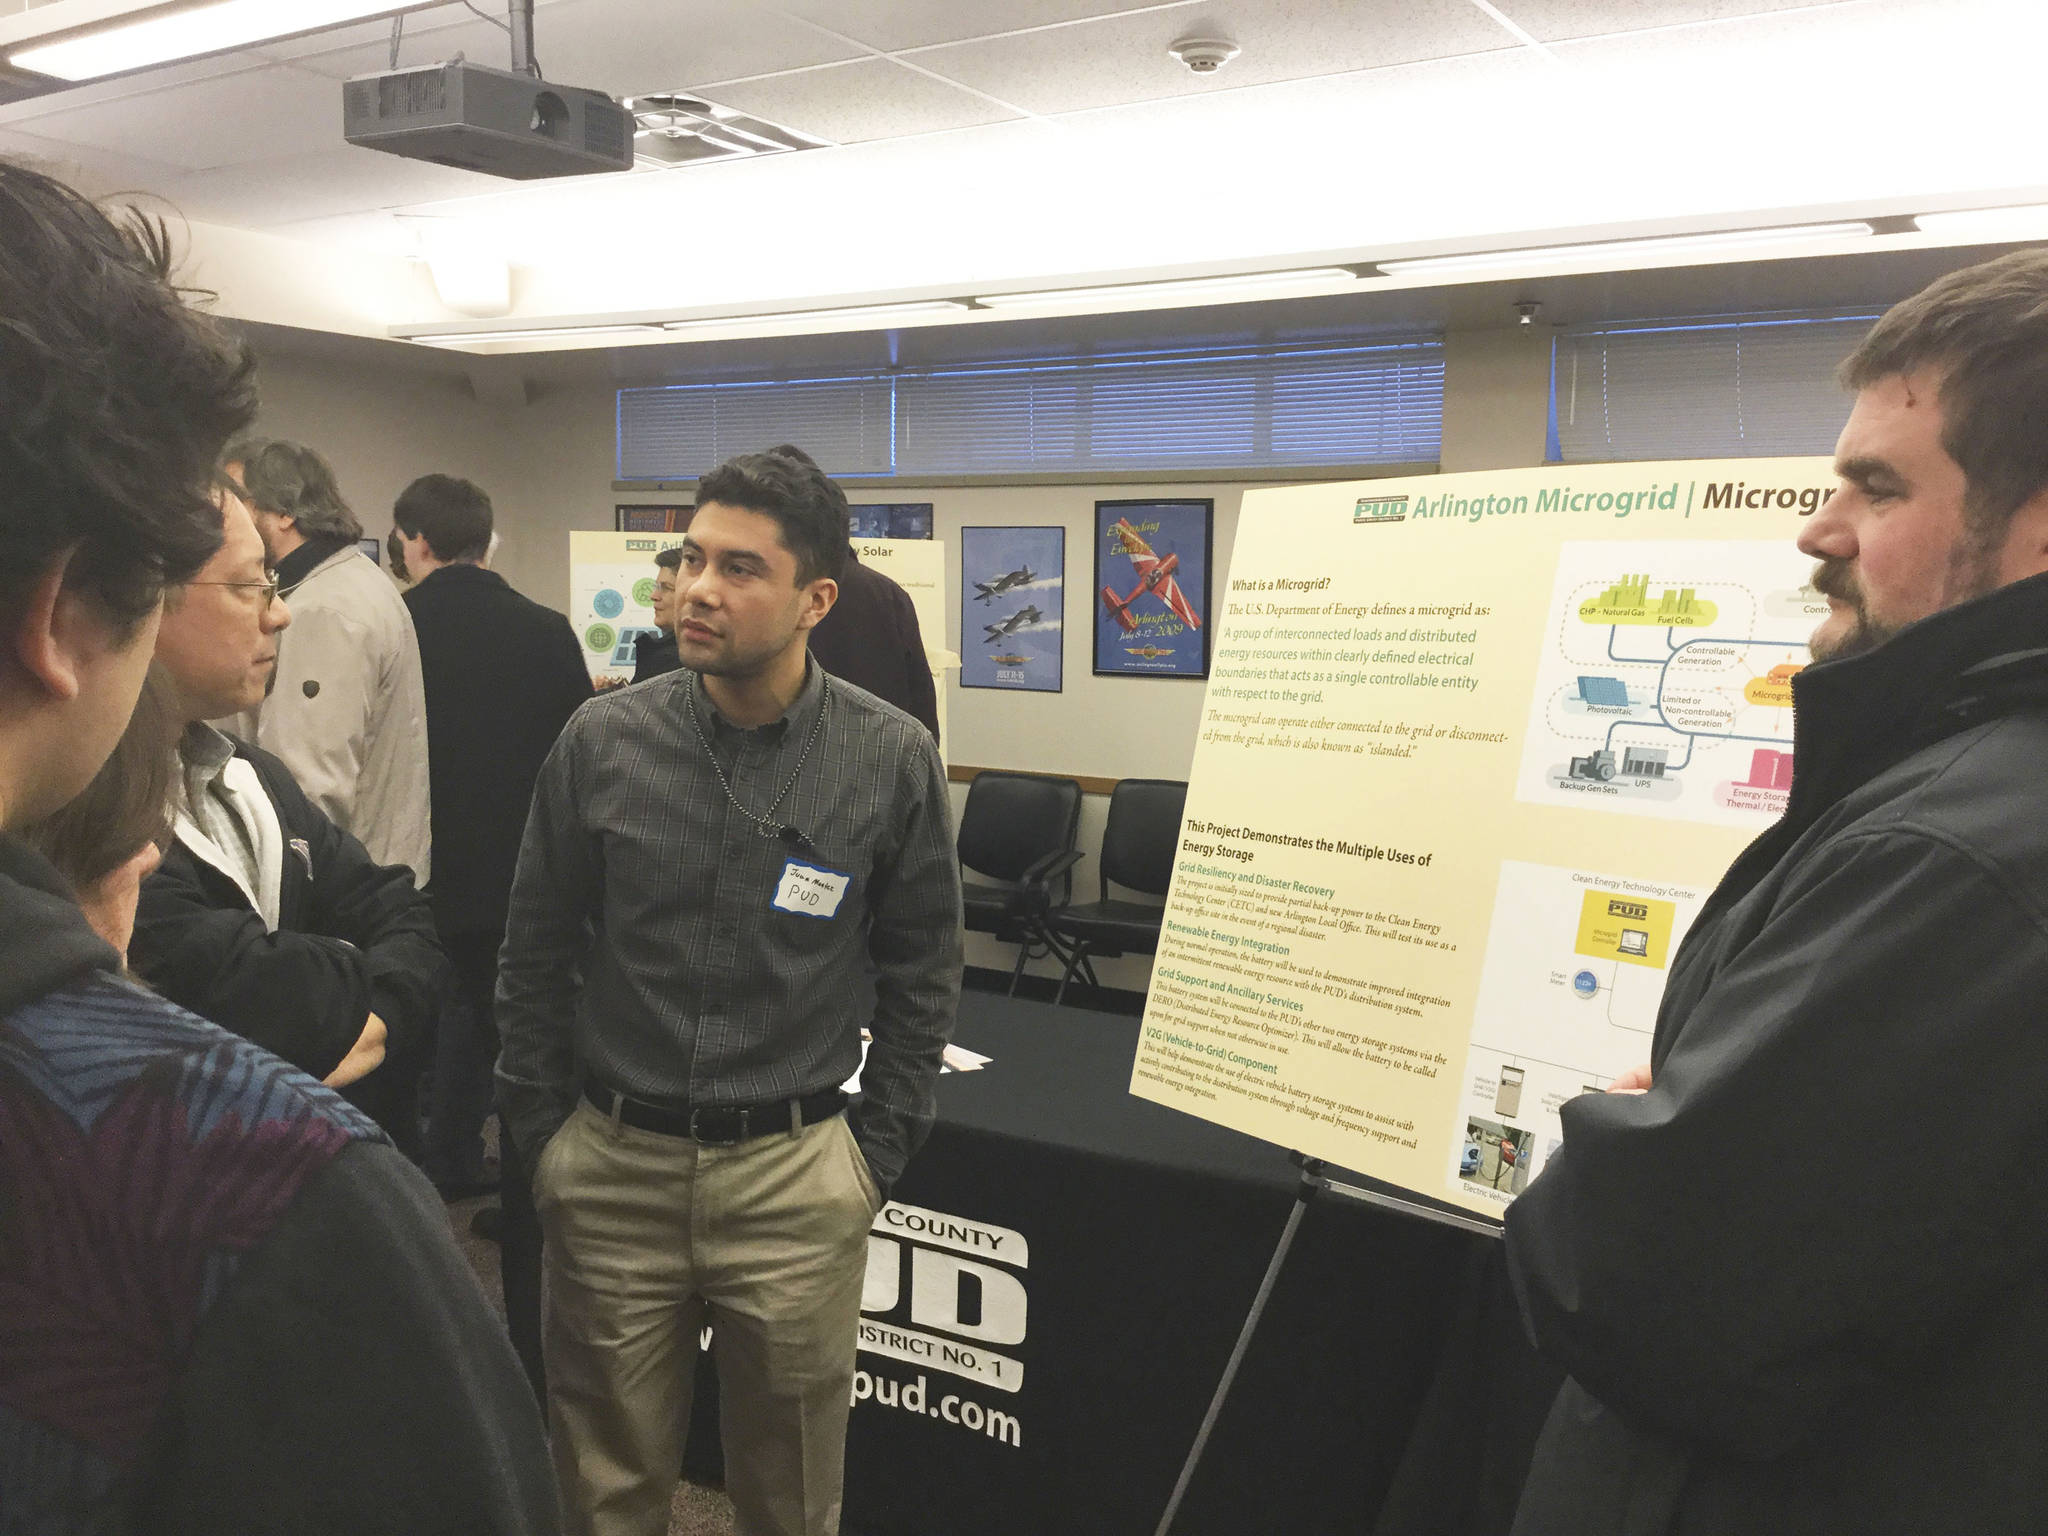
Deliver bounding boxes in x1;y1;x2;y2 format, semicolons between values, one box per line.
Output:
243;328;1550;987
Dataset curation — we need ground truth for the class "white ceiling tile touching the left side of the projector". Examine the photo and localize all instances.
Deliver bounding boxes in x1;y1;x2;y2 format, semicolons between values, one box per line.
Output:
18;66;342;170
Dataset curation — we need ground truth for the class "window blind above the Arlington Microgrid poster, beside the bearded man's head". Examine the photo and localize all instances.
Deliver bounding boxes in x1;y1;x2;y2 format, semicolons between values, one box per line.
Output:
1550;313;1876;463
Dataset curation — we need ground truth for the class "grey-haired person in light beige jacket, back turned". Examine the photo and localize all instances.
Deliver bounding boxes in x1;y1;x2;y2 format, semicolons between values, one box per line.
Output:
225;438;432;887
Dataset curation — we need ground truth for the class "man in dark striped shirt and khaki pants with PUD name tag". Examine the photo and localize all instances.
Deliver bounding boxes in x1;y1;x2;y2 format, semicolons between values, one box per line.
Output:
498;455;961;1536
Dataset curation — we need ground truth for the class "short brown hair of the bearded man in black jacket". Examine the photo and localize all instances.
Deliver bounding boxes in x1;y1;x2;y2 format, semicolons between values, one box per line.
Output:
1841;248;2048;537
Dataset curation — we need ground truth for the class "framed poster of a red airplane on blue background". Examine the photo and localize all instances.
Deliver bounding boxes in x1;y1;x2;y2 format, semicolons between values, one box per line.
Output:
1090;500;1217;678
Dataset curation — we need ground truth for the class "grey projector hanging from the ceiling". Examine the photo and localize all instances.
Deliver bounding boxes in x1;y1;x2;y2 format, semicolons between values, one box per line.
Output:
342;59;633;180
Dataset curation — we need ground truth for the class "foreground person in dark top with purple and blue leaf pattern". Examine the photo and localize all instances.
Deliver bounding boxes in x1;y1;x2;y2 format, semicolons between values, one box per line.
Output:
0;162;555;1536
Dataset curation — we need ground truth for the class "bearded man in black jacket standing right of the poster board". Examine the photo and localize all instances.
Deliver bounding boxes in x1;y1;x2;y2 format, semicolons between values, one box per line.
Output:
1507;250;2048;1536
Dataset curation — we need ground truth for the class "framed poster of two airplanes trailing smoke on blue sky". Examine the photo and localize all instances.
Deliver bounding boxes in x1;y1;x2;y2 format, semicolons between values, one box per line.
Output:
961;528;1067;694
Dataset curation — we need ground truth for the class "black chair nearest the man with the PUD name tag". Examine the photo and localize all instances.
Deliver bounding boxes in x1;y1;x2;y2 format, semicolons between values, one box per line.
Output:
954;770;1081;997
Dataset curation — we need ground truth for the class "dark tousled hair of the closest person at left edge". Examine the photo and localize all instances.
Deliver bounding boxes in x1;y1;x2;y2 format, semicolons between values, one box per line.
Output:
0;160;256;633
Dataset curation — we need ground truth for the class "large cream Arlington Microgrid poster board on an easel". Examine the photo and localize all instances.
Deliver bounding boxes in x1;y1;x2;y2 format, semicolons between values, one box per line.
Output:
1130;459;1831;1217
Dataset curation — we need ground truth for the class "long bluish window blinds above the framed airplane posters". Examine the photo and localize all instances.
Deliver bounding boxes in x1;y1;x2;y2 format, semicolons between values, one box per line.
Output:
618;338;1444;479
